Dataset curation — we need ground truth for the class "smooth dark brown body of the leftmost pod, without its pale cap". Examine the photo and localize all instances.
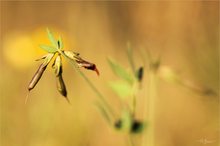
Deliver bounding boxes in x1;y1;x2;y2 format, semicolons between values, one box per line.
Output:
28;63;47;91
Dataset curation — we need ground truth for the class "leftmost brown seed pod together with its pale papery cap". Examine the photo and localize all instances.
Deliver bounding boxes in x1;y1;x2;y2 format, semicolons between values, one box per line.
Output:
28;54;54;91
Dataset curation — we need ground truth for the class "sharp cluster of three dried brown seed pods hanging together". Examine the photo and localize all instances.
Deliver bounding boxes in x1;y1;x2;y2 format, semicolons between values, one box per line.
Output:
28;41;99;101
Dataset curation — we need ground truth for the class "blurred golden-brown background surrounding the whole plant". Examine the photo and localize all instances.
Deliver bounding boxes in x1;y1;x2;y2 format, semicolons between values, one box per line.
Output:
0;1;219;146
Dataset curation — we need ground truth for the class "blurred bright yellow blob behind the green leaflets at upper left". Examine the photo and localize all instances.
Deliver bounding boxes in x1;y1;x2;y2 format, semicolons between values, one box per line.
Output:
3;27;69;70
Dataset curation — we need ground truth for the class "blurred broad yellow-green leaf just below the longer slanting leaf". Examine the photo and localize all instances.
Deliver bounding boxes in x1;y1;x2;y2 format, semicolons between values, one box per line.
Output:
109;81;133;99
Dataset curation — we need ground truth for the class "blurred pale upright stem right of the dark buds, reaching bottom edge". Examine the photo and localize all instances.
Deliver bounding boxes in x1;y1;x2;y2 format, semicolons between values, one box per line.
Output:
141;50;157;146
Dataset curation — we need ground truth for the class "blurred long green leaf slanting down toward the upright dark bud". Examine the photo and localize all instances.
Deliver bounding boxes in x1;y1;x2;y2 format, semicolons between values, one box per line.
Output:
108;59;134;84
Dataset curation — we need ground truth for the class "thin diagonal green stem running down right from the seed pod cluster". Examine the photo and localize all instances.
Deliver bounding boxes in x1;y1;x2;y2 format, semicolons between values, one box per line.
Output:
58;49;115;118
